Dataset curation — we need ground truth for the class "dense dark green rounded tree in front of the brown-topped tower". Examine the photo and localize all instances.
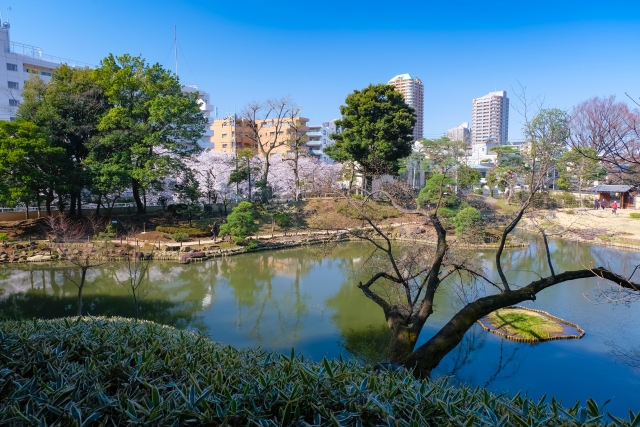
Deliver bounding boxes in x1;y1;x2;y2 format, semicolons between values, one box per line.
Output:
325;84;416;188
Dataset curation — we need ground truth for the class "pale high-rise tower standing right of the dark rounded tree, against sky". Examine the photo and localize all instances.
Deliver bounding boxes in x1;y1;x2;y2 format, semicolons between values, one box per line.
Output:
471;90;509;146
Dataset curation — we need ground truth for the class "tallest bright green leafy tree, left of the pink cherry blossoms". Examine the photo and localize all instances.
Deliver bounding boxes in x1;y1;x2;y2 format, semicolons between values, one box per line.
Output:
90;55;206;213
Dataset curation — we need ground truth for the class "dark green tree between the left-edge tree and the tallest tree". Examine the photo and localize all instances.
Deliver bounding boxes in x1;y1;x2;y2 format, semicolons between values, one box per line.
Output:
18;65;108;215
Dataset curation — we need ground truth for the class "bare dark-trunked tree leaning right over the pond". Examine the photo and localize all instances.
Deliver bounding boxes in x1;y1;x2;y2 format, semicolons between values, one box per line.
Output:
336;110;640;376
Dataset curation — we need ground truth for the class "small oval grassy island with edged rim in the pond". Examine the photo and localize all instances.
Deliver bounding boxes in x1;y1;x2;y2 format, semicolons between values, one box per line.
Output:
478;306;584;343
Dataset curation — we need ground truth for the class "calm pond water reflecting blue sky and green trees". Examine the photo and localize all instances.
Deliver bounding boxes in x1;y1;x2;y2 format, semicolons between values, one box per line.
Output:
0;240;640;416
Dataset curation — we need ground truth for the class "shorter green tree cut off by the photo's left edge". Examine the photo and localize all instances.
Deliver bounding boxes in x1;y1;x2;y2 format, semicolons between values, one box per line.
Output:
0;120;66;218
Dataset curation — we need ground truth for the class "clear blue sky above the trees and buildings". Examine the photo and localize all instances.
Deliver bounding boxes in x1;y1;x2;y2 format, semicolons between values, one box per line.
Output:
8;0;640;140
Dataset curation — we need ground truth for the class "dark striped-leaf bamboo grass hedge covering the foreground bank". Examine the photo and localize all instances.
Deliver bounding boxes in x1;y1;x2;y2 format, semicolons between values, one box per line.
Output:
0;317;640;427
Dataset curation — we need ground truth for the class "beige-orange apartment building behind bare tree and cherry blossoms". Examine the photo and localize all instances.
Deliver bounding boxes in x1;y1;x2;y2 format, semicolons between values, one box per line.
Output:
206;116;309;154
